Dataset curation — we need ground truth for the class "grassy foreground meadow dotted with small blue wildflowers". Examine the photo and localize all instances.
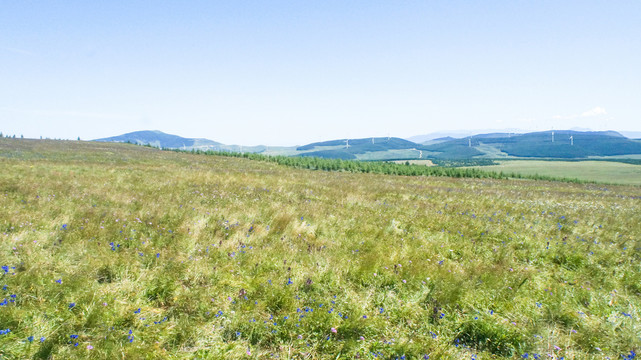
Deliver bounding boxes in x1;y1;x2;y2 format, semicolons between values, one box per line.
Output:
0;139;641;359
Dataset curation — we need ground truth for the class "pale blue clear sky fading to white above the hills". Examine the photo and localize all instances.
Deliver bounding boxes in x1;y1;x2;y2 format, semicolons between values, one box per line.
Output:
0;0;641;146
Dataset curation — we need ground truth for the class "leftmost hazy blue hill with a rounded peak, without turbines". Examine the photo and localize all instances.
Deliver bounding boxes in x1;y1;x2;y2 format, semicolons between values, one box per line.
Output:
94;130;223;150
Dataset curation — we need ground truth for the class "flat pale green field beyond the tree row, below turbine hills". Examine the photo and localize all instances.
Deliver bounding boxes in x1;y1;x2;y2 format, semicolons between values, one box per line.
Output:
477;160;641;185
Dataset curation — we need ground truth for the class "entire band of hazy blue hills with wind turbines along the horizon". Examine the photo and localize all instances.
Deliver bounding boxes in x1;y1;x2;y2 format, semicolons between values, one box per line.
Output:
95;129;641;160
